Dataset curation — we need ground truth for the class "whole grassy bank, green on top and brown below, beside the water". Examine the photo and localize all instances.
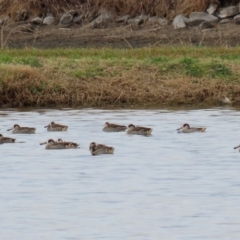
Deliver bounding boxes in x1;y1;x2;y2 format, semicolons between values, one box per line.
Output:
0;47;240;107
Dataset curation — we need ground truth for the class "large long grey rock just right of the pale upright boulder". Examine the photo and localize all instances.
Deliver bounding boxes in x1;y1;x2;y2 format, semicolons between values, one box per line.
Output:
187;12;219;26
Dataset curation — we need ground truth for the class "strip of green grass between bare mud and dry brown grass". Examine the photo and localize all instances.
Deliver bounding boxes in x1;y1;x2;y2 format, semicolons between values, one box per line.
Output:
0;47;240;79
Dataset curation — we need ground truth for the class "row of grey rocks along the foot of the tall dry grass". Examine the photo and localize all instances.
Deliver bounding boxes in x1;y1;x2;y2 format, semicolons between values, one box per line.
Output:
0;3;240;32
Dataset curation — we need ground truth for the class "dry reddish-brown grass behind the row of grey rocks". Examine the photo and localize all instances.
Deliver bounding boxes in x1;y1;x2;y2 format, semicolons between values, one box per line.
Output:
0;0;238;20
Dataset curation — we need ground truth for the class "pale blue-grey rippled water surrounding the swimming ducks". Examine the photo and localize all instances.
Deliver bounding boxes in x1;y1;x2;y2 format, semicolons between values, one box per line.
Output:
0;108;240;240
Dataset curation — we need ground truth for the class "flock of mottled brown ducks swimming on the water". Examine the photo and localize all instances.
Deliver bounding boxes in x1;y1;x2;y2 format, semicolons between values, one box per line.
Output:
0;122;240;155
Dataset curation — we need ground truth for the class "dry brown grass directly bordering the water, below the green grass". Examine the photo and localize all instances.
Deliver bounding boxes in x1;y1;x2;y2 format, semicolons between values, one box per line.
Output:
0;60;240;107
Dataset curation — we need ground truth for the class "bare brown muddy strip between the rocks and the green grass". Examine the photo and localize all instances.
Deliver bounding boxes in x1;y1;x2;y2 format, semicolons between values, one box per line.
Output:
4;23;240;49
